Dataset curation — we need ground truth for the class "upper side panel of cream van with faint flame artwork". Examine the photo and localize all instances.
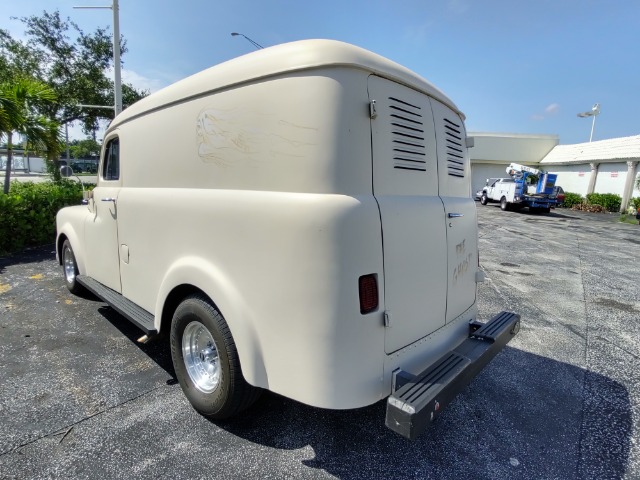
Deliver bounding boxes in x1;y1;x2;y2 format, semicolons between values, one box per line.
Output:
120;68;371;195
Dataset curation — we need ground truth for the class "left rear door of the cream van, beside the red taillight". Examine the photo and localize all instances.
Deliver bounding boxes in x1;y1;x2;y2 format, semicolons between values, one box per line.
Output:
368;75;447;353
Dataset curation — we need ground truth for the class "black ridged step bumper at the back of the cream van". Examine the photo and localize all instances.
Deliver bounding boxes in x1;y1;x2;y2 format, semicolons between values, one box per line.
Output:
386;312;520;440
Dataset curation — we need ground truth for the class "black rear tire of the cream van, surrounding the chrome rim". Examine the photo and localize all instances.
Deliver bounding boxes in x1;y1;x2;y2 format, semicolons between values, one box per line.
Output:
170;294;262;420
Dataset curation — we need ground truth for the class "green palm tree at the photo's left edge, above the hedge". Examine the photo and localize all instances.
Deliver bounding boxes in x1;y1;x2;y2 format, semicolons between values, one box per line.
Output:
0;78;59;194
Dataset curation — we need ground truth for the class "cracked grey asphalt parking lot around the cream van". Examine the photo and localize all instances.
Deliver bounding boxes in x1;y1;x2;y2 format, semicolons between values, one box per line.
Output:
0;204;640;479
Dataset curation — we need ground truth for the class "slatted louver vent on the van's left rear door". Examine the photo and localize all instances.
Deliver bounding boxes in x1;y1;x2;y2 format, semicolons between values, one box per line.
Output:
389;97;427;172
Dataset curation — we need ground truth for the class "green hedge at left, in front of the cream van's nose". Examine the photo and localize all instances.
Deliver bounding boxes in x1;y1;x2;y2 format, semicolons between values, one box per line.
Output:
0;180;91;255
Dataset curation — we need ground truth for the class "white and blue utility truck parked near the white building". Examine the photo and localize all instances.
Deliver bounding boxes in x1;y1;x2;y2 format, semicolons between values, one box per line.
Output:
480;163;558;213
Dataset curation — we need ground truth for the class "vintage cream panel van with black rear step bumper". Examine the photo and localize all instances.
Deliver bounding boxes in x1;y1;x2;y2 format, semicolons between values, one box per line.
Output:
57;40;520;438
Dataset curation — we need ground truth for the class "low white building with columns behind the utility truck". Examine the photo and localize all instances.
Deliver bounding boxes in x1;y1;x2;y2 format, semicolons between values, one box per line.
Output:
468;132;640;210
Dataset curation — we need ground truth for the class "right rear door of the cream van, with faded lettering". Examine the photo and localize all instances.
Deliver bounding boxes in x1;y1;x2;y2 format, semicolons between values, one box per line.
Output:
431;99;478;322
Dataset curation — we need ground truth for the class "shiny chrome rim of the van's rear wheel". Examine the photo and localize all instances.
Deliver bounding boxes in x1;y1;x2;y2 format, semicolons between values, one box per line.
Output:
182;321;220;393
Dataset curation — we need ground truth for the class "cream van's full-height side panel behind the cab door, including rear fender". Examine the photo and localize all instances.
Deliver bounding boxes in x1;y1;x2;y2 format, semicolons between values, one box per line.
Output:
118;68;388;408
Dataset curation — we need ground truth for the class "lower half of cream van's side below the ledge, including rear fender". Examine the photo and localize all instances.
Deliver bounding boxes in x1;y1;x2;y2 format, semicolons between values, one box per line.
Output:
119;189;384;408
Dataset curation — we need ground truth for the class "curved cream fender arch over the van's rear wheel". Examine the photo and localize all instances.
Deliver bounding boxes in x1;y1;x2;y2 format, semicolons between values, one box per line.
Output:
155;256;269;388
